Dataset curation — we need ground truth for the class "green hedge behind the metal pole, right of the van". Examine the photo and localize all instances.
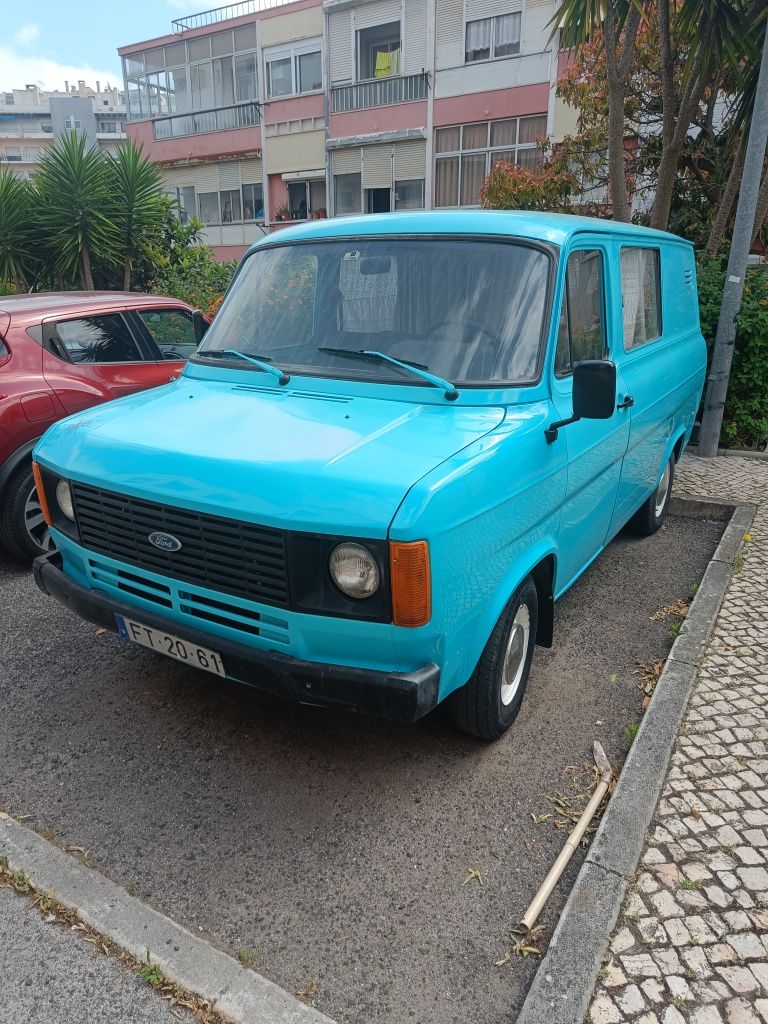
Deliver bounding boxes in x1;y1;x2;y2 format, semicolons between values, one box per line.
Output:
698;257;768;449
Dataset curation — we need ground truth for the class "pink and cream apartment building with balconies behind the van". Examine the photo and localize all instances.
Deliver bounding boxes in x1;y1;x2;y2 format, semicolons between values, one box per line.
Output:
119;0;558;258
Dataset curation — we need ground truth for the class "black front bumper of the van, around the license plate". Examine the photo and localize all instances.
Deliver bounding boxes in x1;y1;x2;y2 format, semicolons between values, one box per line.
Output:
33;551;440;722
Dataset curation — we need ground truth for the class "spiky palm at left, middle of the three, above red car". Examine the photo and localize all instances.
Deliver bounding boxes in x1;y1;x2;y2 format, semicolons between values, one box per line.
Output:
37;131;117;290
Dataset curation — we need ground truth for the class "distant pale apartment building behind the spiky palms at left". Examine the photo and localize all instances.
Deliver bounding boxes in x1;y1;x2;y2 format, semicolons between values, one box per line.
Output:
0;81;128;177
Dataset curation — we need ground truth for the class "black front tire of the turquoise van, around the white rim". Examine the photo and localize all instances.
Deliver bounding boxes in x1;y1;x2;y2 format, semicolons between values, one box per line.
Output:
447;577;539;739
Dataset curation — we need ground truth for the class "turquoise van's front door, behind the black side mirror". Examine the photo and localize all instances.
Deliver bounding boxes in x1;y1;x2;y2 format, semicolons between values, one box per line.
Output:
552;238;630;593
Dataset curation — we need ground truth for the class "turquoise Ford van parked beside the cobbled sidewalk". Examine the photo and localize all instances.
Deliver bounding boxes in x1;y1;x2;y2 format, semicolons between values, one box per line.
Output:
34;211;706;739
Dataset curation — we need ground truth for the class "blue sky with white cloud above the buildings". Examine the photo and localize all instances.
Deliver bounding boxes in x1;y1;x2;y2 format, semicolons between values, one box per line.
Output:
0;0;221;91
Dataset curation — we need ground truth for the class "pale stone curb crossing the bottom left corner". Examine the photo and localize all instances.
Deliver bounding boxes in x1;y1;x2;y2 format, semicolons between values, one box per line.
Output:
0;818;334;1024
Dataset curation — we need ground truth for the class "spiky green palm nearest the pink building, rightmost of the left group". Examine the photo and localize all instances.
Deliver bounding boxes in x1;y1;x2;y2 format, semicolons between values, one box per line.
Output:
108;140;165;292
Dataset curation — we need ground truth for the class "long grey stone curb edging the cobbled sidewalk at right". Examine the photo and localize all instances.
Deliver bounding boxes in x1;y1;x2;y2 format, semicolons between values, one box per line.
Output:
517;496;754;1024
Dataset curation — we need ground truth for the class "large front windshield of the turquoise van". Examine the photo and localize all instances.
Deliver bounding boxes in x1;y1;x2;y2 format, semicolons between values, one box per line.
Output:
200;238;550;385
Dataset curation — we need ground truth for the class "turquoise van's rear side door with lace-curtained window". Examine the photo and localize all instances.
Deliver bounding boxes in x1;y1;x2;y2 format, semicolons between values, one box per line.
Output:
611;245;688;532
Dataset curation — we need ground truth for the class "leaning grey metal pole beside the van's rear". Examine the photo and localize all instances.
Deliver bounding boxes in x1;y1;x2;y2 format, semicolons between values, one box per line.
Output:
698;23;768;459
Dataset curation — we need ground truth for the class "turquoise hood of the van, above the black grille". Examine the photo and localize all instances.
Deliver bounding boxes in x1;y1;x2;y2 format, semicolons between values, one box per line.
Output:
35;377;505;538
